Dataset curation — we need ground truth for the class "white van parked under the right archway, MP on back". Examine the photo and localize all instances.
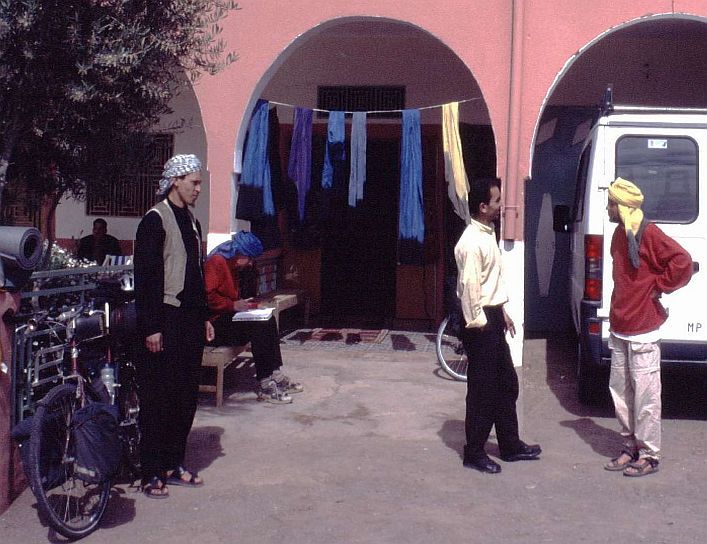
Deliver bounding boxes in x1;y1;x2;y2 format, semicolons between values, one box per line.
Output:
554;88;707;403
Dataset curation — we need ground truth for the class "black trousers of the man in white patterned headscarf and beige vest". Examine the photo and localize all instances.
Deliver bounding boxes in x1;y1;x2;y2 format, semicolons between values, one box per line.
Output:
137;304;205;479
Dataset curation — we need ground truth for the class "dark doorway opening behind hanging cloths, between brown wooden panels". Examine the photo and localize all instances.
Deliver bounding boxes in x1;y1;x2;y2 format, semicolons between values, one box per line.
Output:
321;138;400;328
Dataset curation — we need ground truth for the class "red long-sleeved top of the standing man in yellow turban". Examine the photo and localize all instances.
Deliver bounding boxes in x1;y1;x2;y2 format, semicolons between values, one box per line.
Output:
609;223;692;336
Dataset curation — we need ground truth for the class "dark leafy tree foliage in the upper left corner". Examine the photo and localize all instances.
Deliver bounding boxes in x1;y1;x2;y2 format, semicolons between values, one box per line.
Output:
0;0;238;217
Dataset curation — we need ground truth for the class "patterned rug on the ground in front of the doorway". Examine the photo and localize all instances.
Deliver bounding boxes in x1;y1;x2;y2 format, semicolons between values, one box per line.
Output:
280;328;435;352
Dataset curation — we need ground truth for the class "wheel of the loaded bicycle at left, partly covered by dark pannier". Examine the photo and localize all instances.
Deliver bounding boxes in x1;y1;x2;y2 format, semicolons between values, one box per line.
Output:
29;383;111;539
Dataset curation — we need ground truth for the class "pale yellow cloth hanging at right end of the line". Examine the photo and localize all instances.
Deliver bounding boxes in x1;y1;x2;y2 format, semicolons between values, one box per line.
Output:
442;102;471;225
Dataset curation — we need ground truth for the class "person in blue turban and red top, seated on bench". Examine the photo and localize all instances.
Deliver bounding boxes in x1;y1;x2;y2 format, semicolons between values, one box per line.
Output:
204;231;304;404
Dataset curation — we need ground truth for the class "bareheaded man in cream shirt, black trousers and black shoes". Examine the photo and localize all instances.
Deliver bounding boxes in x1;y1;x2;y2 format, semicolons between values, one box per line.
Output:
454;178;542;474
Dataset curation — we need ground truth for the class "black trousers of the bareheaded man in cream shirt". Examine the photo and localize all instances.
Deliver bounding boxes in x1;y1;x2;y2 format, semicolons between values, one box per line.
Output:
461;306;520;459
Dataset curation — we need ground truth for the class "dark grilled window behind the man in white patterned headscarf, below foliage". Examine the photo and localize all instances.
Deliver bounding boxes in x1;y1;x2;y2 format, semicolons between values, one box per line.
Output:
86;134;174;217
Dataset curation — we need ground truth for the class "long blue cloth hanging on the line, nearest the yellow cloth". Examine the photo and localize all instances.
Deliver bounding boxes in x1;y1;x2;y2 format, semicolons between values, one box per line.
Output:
399;110;425;264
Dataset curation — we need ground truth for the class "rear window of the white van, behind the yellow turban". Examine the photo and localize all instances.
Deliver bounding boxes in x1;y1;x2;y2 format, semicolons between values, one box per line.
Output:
616;136;698;223
